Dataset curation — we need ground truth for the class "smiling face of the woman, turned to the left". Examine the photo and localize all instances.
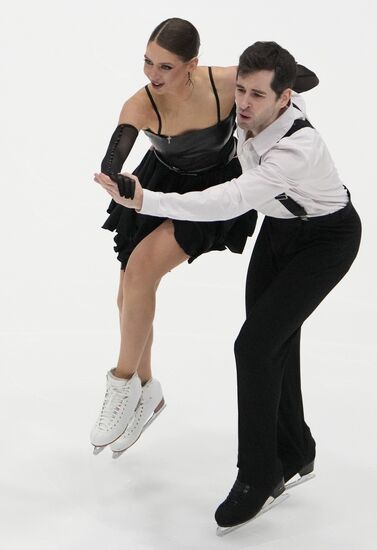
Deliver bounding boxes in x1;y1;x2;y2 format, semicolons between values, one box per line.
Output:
144;42;191;94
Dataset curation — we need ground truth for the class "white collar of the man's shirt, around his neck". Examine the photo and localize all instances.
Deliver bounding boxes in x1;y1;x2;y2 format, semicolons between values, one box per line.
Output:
239;102;305;157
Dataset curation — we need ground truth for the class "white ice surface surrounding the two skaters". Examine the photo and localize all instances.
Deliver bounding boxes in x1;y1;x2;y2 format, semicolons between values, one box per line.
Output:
0;0;377;550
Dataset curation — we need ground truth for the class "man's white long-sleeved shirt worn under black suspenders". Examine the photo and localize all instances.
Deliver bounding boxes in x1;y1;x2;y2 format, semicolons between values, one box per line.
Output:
139;95;348;221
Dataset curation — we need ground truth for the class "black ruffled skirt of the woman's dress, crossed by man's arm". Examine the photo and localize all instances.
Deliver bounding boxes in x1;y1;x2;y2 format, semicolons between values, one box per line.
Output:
102;149;257;269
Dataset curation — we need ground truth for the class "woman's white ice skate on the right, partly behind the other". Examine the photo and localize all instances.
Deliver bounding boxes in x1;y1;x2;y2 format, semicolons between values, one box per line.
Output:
111;378;166;458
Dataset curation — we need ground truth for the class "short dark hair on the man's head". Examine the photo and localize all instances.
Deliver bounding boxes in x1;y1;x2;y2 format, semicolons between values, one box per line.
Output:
237;42;297;97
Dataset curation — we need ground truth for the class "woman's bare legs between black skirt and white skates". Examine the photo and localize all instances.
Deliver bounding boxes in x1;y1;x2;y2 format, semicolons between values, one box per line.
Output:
114;220;188;382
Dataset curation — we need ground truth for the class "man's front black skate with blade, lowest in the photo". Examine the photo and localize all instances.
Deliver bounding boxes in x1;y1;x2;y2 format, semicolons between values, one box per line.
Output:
215;479;289;537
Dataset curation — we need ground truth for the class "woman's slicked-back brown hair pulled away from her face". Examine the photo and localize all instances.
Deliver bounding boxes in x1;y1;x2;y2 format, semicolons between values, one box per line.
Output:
149;17;200;62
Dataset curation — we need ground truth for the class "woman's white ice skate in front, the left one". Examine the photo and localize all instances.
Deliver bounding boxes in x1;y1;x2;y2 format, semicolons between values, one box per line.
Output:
90;371;141;455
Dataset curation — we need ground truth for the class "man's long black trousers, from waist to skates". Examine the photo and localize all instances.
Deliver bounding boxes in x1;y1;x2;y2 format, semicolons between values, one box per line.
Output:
235;202;361;488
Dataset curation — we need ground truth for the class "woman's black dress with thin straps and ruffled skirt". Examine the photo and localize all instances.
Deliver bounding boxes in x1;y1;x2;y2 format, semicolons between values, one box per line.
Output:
103;68;257;269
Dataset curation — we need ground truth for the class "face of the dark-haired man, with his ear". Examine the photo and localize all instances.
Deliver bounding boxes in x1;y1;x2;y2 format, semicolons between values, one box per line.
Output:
236;70;291;136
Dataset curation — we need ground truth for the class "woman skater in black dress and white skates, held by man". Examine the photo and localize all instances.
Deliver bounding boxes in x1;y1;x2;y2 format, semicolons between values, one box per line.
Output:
91;18;318;457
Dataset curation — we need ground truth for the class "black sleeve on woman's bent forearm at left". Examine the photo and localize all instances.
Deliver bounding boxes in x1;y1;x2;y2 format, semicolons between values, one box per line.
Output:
101;124;139;176
